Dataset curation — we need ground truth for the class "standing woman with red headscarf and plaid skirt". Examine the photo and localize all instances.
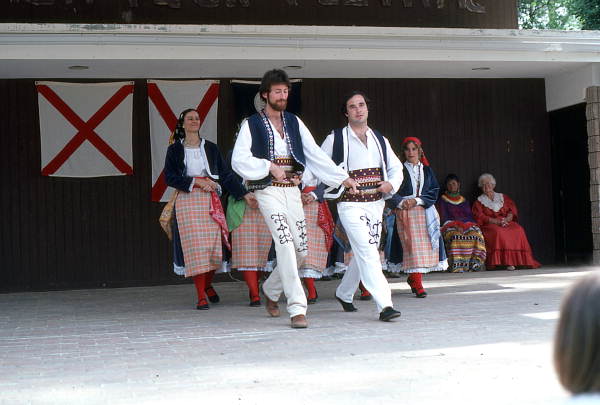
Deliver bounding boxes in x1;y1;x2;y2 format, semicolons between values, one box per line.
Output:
386;137;448;298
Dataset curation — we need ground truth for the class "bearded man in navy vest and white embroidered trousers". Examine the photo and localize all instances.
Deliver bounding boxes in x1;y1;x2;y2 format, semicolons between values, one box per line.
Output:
231;69;357;328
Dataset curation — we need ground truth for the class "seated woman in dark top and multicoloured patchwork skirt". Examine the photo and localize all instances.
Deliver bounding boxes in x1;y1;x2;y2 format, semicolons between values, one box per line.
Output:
436;174;486;273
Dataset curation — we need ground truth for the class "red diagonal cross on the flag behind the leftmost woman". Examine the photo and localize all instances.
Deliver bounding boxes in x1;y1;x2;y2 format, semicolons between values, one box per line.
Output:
148;83;219;201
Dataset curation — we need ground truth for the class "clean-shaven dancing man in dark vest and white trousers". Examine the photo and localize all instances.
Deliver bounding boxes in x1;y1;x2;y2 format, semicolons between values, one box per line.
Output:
322;91;403;322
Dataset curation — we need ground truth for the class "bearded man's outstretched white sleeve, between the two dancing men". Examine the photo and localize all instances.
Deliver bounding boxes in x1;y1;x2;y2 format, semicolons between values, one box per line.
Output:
298;118;348;187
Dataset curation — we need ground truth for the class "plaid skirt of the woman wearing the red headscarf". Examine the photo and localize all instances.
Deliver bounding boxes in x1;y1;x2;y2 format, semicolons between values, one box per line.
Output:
396;205;440;271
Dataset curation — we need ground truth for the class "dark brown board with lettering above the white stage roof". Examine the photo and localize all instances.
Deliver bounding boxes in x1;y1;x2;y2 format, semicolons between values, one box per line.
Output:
0;0;517;28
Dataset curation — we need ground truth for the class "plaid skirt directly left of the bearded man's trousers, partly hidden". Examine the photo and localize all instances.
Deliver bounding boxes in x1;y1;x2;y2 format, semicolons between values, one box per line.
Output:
231;205;273;269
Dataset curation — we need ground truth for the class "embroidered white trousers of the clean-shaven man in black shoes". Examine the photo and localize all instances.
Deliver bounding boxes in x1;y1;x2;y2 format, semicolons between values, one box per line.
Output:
335;200;393;312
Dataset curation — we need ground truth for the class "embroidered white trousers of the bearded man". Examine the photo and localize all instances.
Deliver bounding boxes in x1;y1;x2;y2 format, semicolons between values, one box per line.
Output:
254;186;308;317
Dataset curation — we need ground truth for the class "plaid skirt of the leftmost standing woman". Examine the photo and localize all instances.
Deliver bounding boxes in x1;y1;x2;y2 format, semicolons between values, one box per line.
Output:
175;188;223;277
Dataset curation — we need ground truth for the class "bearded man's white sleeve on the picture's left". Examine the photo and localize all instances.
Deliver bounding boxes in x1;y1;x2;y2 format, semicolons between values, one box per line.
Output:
231;120;271;180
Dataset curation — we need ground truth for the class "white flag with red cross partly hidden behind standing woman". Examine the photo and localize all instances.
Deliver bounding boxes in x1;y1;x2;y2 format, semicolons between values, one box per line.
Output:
148;80;219;201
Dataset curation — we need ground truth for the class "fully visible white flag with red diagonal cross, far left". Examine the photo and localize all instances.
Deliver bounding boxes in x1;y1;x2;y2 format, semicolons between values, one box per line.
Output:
36;81;133;177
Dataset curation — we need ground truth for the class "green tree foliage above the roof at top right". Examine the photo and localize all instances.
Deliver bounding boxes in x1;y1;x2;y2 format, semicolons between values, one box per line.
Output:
519;0;584;30
